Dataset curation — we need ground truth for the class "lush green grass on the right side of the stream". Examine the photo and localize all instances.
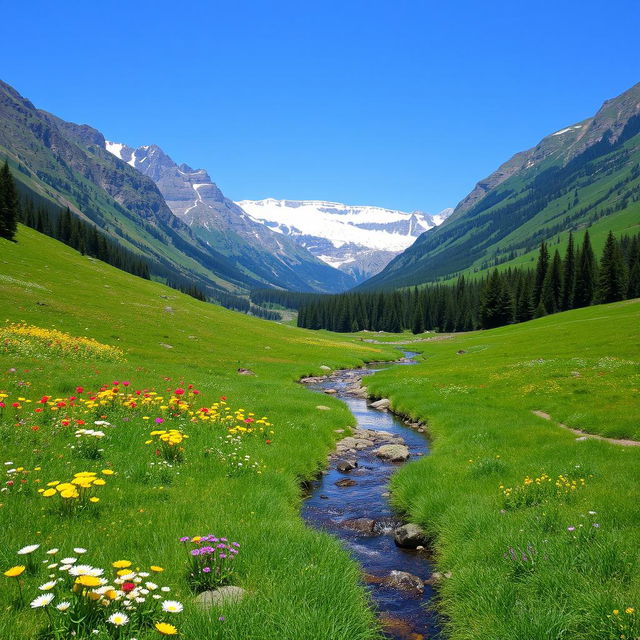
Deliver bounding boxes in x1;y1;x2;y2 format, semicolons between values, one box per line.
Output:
367;301;640;640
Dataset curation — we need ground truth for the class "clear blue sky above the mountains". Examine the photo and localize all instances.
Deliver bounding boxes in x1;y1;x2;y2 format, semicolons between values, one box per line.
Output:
0;0;640;212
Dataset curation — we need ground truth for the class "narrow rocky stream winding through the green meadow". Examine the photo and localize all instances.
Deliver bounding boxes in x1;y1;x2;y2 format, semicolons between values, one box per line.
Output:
302;352;439;640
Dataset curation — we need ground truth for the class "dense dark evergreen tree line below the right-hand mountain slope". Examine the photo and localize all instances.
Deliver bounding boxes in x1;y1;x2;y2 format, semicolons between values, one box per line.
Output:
298;231;640;334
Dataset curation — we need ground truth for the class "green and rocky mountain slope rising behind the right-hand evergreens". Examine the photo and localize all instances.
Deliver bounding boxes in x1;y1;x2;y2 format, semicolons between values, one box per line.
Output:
360;84;640;289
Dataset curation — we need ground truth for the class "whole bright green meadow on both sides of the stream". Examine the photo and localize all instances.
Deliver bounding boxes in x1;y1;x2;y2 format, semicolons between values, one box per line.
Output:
0;227;640;640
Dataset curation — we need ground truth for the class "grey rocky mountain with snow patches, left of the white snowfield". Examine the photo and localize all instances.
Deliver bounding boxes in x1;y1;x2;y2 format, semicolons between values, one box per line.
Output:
105;141;355;292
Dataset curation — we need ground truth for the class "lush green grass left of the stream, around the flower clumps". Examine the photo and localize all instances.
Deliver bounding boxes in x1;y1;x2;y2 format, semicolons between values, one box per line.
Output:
0;227;397;640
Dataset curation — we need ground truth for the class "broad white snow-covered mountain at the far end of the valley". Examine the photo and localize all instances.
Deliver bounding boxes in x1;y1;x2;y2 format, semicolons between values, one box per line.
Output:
236;198;453;281
